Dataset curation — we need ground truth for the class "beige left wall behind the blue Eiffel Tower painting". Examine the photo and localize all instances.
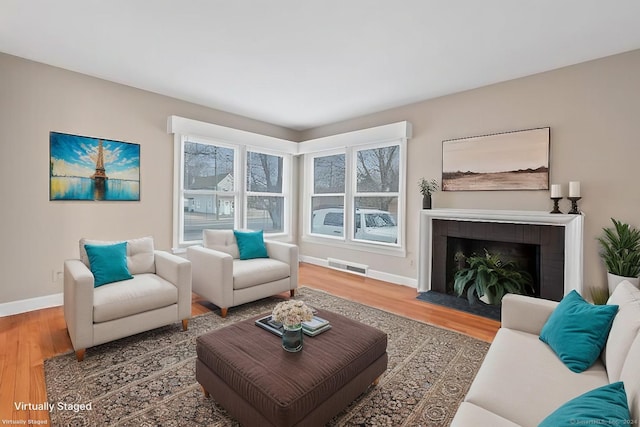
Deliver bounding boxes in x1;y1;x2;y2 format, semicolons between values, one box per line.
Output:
0;53;299;304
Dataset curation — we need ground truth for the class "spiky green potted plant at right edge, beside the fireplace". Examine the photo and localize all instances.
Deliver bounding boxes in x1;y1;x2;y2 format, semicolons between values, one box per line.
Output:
598;218;640;294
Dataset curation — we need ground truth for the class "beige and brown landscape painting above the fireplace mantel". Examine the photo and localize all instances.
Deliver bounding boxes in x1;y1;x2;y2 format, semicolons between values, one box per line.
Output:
442;127;550;191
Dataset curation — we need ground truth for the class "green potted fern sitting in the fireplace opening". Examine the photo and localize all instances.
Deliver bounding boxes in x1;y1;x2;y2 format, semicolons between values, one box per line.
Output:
453;249;535;305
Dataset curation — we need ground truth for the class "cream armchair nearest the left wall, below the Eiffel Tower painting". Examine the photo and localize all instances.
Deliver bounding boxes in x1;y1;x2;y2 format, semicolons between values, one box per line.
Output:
64;237;191;361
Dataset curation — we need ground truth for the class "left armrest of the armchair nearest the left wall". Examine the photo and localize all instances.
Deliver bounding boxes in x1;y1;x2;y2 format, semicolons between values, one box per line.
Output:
64;259;94;350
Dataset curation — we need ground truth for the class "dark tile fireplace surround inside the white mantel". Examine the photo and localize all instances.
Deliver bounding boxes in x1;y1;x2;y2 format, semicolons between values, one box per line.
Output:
431;218;565;301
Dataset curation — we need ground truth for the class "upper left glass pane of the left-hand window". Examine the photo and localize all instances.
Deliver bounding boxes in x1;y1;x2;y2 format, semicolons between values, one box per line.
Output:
184;142;234;191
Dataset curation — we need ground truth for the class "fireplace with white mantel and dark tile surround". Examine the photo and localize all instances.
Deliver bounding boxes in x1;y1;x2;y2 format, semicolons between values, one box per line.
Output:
418;209;583;301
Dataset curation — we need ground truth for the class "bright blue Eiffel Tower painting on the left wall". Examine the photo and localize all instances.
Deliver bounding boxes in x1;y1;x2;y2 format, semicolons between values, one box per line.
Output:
49;132;140;201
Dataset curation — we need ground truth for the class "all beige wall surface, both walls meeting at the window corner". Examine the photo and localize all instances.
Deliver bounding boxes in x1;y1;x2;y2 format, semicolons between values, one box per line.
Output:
0;47;640;304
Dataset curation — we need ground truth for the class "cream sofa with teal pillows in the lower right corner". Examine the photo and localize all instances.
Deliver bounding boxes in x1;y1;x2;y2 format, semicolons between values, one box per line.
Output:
451;282;640;427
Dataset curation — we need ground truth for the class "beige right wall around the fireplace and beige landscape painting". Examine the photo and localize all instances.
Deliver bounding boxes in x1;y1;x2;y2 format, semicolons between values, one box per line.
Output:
301;50;640;287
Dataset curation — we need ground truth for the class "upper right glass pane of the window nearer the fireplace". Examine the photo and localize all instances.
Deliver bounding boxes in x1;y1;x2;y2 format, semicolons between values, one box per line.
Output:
356;145;400;193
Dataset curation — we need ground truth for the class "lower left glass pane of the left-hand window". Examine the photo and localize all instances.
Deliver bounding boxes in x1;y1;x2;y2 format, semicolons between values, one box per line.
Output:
183;193;235;241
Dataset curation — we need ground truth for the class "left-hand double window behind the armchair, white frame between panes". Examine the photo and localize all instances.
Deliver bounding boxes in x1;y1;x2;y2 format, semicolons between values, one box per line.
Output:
177;137;291;246
